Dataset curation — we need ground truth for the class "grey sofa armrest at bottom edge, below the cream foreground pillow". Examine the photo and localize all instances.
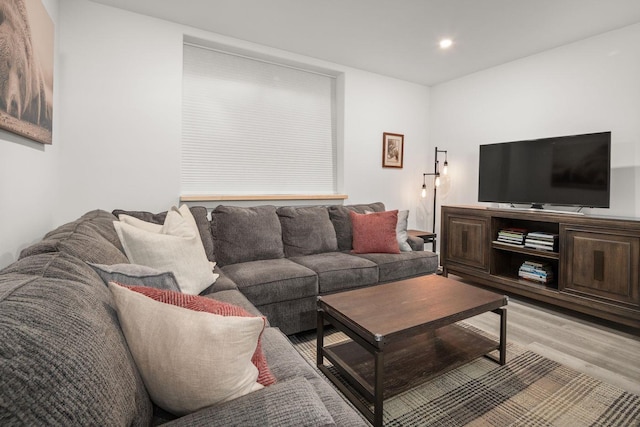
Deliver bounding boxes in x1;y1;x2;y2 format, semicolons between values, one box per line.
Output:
164;377;336;427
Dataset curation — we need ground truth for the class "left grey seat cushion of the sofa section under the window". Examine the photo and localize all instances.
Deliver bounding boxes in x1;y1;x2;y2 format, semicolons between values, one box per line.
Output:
222;258;318;307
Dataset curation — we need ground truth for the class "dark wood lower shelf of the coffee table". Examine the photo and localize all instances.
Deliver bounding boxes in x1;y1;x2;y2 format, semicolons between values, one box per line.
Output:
321;324;500;402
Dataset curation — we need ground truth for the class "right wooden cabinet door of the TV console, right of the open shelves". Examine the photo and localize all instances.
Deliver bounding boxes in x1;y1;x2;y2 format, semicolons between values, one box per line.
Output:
560;227;640;306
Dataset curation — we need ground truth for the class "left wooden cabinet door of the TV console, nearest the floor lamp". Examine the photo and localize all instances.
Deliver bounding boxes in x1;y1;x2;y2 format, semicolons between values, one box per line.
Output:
445;215;489;270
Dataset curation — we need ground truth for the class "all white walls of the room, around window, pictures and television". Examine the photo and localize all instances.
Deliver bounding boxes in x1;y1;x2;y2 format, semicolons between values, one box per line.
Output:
11;0;640;267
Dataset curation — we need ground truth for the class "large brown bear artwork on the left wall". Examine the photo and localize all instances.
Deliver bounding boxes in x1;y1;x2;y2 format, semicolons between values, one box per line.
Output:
0;0;54;144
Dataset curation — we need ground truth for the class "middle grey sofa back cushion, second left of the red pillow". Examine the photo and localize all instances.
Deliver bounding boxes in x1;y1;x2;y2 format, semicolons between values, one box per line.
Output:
277;206;338;257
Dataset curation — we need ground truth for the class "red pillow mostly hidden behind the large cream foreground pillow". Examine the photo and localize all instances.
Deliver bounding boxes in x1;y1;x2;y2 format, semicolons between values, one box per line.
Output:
118;283;276;387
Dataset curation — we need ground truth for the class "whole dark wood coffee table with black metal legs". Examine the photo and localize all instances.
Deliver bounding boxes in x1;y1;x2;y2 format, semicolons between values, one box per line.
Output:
317;275;508;426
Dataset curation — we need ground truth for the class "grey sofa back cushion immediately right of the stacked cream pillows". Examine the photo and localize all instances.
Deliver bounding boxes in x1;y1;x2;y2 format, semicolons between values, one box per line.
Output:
211;205;284;266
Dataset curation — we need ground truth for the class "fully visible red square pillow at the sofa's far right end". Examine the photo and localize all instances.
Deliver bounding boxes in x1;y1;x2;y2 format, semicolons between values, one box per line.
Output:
349;210;400;254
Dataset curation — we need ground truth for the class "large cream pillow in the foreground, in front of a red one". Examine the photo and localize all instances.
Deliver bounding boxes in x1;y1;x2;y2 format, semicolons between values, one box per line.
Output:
109;282;264;415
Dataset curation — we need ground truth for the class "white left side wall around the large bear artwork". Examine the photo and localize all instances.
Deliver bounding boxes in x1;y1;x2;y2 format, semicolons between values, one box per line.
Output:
0;0;60;268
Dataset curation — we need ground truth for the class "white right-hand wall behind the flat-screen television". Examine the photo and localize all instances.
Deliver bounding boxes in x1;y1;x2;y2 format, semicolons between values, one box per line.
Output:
429;24;640;226
